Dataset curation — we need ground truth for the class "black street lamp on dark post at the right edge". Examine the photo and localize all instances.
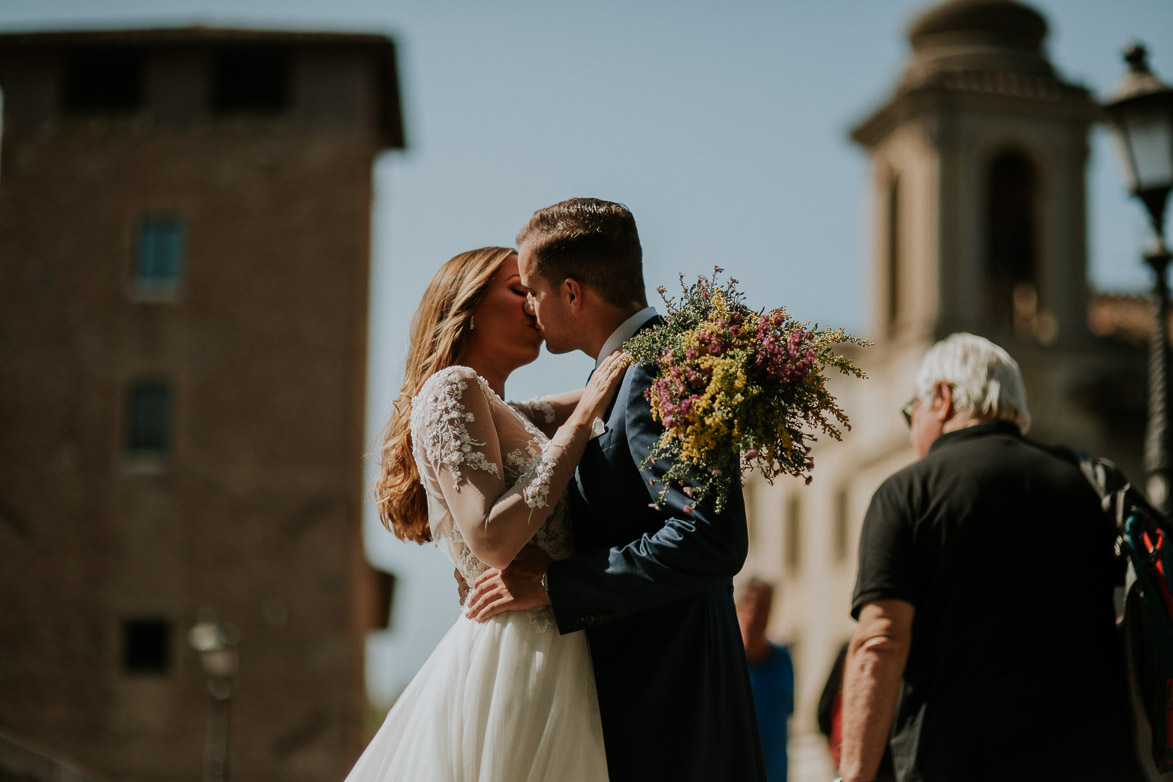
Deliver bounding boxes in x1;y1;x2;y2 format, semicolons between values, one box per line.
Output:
1104;45;1173;512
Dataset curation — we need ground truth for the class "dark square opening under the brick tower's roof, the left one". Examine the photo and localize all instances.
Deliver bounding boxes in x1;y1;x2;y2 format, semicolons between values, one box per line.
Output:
61;46;145;114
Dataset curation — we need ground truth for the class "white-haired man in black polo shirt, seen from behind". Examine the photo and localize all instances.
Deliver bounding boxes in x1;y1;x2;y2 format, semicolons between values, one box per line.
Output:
840;334;1138;782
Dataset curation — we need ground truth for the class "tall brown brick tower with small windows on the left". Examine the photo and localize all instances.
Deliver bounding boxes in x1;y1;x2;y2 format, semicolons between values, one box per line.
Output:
0;28;404;781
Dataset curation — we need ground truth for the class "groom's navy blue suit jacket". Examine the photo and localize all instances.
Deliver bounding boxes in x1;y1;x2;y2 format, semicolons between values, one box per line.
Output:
547;321;766;782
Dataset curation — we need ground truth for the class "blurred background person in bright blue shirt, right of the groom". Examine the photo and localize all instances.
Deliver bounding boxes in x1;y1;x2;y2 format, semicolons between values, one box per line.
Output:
737;578;794;782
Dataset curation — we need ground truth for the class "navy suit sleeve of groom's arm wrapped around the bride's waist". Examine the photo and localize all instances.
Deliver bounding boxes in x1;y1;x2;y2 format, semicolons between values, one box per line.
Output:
547;366;748;633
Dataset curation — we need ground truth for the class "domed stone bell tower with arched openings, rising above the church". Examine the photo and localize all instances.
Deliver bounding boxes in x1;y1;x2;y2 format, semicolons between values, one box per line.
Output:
852;0;1097;345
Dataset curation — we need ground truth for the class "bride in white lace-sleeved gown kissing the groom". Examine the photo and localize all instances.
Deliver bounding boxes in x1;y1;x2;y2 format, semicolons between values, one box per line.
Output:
347;247;625;782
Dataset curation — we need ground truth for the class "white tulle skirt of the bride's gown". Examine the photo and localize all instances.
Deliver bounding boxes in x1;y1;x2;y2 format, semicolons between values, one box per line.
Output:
346;613;606;782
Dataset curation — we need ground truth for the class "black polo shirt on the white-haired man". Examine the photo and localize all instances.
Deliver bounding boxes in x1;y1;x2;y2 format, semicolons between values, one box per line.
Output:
852;421;1127;781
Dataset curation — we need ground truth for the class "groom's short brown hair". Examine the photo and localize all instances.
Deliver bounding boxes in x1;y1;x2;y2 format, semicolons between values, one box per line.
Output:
517;198;647;307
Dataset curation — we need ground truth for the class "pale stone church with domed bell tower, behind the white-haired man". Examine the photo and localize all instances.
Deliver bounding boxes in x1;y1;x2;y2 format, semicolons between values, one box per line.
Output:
744;0;1145;782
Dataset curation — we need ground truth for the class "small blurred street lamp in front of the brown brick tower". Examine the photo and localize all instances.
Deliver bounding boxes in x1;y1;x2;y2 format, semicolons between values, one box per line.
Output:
188;618;240;782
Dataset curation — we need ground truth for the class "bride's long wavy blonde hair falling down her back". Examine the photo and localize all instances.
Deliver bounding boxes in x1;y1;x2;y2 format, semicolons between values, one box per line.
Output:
374;247;516;543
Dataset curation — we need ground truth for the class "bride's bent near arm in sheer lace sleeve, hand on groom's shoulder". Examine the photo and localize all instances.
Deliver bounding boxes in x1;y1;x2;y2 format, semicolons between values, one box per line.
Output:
422;360;625;567
